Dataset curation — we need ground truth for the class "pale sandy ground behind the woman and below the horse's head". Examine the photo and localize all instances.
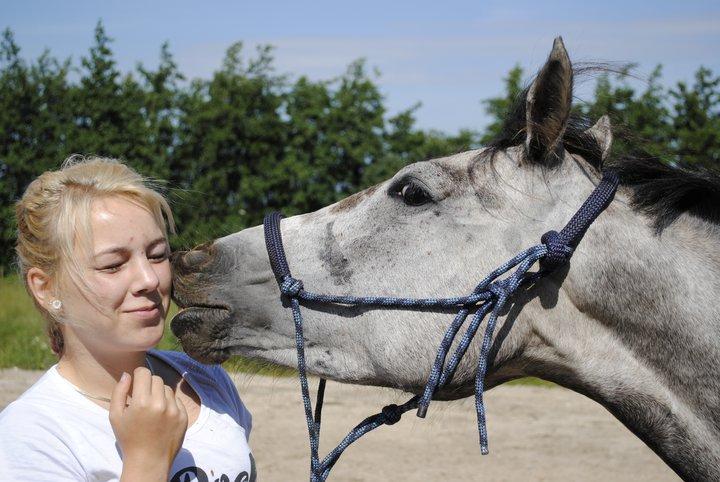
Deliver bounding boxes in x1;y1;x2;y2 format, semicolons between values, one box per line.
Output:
0;369;679;482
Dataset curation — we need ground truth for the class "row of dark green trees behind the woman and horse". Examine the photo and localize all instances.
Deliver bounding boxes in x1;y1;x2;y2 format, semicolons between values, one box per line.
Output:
0;23;720;269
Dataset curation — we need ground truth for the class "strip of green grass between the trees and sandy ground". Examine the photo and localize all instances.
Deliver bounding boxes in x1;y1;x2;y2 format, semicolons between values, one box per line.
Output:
0;275;555;387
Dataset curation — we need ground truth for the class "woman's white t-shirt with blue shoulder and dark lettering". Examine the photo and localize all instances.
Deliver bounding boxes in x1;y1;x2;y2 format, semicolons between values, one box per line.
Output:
0;350;257;482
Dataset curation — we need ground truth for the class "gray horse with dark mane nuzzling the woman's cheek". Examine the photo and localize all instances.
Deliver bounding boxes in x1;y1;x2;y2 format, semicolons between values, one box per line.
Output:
172;39;720;480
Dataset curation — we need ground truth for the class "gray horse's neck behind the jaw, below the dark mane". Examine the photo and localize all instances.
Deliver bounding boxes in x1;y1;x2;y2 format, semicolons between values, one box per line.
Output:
550;210;720;480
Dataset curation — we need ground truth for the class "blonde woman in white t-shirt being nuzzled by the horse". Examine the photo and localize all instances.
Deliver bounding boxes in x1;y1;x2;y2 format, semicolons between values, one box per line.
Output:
0;158;255;482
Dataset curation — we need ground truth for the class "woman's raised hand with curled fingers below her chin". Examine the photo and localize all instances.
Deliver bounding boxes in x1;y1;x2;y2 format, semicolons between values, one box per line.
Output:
110;367;188;481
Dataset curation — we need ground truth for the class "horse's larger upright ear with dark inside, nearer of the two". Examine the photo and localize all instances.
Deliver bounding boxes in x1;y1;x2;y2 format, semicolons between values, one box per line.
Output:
525;37;573;163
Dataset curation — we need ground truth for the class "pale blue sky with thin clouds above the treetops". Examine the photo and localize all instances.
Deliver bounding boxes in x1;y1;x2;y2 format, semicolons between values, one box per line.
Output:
0;0;720;133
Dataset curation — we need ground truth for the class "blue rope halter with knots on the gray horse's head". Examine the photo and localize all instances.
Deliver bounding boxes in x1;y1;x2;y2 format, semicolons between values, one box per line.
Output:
264;172;618;482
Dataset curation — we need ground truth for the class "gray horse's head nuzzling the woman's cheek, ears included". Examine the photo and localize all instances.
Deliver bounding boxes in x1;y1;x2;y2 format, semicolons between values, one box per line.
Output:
172;39;611;397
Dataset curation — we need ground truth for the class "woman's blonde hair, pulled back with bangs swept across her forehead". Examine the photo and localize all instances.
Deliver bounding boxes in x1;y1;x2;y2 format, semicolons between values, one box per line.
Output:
15;156;175;356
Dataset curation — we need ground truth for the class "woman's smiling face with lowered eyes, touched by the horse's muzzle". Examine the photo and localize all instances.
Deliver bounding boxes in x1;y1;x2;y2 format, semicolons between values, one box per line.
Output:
62;197;172;353
